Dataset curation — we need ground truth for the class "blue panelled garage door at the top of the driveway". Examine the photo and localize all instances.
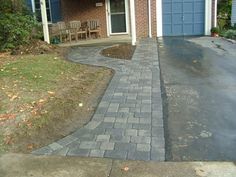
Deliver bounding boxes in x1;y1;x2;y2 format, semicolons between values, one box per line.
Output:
162;0;205;36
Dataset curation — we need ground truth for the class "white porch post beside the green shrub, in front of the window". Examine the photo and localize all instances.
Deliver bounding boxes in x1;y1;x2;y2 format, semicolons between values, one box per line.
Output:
40;0;50;44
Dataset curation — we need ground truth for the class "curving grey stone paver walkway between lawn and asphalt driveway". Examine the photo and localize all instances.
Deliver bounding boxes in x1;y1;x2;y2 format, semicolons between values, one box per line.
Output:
33;39;165;161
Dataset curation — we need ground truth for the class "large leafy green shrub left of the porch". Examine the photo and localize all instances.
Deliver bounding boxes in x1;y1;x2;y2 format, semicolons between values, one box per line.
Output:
0;0;37;50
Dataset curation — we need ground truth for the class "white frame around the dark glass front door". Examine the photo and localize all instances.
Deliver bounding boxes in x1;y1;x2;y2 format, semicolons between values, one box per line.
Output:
106;0;129;36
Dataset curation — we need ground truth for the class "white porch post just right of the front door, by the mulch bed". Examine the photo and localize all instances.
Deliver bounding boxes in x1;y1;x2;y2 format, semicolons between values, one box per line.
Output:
130;0;137;45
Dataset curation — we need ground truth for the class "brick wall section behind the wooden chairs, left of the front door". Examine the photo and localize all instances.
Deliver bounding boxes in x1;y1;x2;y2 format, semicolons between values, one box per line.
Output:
61;0;107;37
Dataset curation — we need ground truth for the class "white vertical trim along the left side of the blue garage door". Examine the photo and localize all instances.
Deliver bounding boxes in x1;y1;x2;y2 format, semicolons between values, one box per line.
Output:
156;0;163;37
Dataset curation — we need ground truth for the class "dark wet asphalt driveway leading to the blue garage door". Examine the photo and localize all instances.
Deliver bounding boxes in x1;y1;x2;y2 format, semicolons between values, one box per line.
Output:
158;37;236;161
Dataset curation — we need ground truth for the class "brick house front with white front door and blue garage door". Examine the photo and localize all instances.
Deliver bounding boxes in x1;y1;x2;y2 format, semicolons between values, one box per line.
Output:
27;0;217;41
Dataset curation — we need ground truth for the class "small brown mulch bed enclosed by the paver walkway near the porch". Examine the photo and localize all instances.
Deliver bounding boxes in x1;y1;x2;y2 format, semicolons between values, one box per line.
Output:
101;44;136;60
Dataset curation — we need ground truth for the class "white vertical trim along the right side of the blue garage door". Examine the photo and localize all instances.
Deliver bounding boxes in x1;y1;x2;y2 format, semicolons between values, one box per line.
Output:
205;0;212;35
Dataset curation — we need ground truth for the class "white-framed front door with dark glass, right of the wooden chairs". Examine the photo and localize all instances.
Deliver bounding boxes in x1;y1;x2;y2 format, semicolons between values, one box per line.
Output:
109;0;127;34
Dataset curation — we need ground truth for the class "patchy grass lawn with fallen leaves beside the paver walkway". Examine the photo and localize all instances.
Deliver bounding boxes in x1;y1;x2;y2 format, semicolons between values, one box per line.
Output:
0;51;112;152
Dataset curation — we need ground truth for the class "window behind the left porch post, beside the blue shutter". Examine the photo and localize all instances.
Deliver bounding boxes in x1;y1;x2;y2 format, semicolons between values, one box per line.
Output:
34;0;52;22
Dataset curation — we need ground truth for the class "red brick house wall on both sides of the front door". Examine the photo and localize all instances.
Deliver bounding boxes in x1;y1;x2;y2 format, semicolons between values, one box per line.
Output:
61;0;151;38
